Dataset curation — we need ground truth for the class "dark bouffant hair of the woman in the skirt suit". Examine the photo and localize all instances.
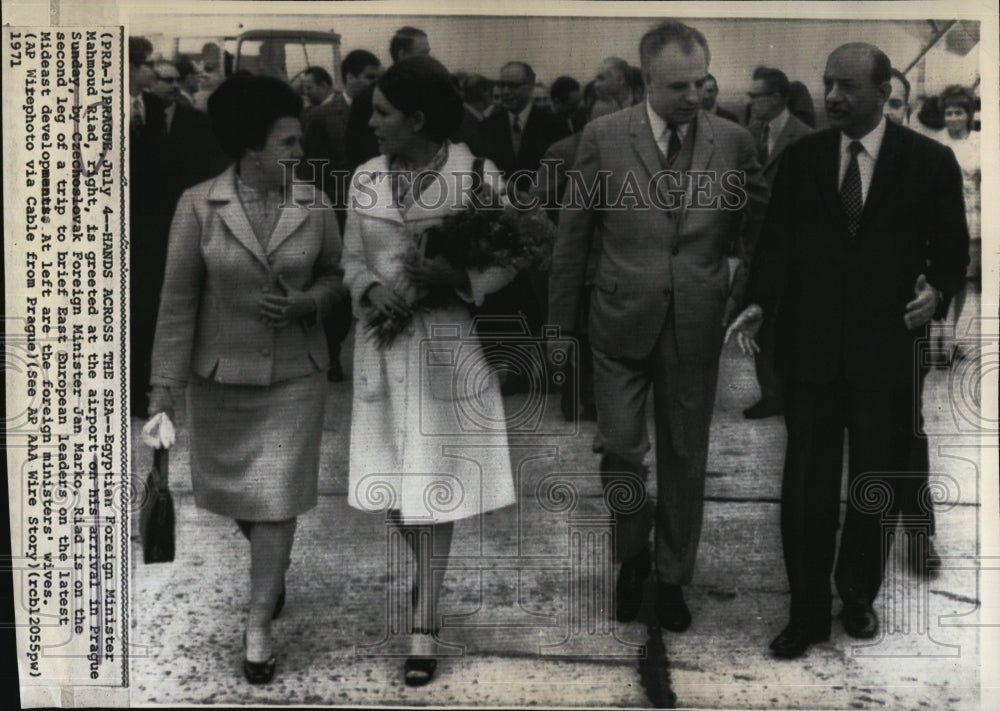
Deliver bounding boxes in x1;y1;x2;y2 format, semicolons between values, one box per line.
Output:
208;75;302;160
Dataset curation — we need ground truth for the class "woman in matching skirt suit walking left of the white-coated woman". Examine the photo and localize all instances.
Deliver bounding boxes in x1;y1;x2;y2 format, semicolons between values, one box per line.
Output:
149;76;343;684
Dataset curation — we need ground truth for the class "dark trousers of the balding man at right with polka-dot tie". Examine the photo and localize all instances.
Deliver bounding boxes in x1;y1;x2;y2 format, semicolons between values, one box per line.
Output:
781;377;926;623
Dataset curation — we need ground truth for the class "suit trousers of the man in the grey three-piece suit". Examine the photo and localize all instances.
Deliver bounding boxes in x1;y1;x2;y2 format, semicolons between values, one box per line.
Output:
593;315;719;585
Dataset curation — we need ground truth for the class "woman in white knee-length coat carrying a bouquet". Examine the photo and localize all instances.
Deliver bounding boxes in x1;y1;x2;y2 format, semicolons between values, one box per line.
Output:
342;57;514;686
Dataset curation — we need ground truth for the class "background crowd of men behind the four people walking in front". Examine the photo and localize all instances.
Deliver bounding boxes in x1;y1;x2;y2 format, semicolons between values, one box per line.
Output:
129;27;980;418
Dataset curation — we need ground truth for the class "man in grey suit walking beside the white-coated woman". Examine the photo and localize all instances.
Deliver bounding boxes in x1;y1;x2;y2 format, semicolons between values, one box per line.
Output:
549;20;766;632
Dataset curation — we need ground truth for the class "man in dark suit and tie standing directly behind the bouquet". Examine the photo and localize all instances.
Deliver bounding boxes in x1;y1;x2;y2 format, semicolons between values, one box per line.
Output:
479;62;569;395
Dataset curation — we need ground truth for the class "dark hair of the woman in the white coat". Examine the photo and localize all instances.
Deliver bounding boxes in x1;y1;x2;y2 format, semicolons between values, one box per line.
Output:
376;56;462;141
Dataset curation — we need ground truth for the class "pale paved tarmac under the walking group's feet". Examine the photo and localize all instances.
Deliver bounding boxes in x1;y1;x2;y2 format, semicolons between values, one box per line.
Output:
132;324;985;709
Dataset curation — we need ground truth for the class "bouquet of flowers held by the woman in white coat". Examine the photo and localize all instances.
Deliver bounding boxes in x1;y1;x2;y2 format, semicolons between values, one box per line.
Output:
365;205;555;349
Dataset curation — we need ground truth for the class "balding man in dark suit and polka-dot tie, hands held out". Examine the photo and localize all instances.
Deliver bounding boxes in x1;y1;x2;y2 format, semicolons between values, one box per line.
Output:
727;43;969;658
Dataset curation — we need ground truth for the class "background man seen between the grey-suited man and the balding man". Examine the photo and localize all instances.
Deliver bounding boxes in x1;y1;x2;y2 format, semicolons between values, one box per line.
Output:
743;67;812;420
